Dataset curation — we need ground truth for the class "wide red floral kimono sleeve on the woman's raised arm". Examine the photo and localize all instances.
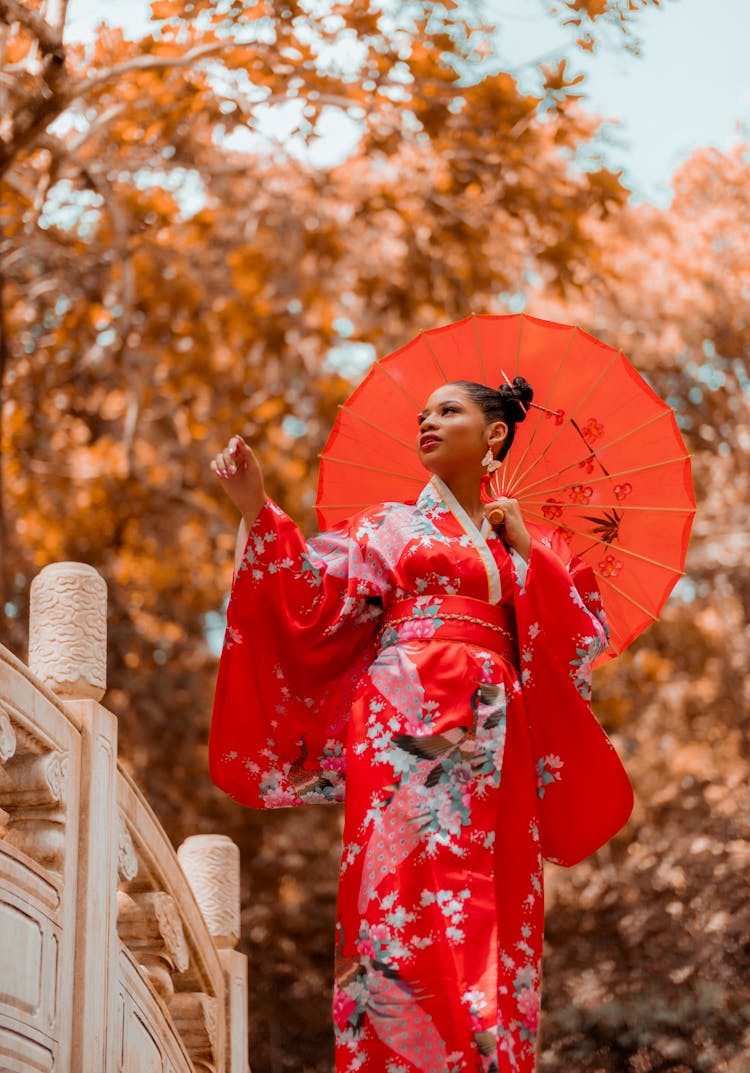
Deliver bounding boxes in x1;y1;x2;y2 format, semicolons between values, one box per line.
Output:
209;501;389;808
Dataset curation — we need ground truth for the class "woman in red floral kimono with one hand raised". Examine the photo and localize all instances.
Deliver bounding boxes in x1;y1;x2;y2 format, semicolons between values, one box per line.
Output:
210;378;630;1073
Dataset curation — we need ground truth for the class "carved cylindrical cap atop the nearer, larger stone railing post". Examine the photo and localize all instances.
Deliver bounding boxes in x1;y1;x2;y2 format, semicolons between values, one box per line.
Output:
29;562;107;701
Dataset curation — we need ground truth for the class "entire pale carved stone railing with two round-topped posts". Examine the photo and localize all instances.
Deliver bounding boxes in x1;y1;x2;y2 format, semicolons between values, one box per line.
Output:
0;563;249;1073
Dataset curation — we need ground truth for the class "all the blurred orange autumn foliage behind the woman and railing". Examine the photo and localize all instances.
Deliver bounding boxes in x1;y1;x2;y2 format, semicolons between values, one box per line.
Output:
0;0;750;1073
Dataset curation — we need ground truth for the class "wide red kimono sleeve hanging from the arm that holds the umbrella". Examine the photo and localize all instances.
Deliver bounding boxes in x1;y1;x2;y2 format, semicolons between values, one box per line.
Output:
514;537;633;865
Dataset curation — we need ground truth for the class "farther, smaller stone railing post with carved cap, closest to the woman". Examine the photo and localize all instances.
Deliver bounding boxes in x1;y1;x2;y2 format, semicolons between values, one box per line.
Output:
177;835;250;1073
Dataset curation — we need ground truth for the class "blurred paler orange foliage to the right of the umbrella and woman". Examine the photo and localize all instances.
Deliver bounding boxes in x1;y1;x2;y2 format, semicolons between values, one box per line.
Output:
538;143;750;1073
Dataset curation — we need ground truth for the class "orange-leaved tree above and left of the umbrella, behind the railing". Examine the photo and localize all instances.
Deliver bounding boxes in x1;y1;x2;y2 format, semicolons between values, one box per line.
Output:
0;0;690;1069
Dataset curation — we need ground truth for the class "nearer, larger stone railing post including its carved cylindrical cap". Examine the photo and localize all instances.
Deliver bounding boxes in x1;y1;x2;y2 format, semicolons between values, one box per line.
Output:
29;562;118;1071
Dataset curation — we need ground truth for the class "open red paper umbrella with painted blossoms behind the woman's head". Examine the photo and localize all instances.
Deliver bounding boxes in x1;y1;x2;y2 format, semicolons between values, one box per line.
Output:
317;313;695;655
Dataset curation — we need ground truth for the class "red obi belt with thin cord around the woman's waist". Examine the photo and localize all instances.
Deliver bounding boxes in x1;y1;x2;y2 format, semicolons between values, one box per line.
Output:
378;596;518;667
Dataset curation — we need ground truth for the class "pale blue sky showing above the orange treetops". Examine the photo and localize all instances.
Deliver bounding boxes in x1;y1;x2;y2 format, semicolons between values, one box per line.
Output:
67;0;750;207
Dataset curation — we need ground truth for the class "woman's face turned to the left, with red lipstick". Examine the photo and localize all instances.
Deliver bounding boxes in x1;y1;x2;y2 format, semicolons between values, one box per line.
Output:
416;384;508;476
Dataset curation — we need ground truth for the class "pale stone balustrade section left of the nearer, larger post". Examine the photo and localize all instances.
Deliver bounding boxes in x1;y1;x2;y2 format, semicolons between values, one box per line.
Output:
0;647;80;1071
